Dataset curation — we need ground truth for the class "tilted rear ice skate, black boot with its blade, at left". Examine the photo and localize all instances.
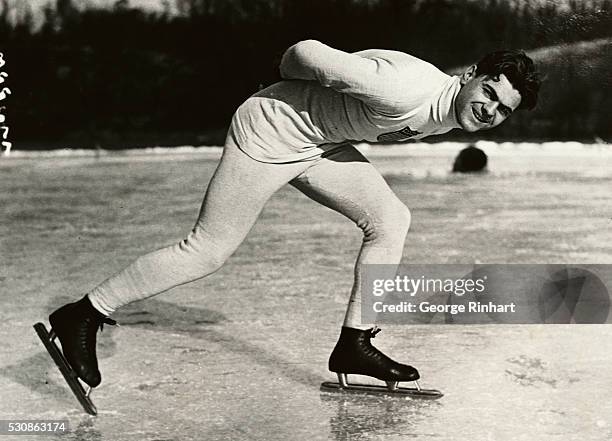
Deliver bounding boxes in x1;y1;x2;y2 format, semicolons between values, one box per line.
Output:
34;297;116;415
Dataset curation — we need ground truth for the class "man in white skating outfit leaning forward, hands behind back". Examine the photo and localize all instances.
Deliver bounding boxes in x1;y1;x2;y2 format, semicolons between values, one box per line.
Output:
44;40;540;387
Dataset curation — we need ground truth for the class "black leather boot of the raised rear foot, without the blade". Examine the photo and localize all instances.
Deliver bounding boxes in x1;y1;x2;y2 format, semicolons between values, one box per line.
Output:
49;296;117;387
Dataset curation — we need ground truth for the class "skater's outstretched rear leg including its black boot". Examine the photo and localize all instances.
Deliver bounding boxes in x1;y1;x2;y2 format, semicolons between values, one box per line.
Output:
49;137;311;387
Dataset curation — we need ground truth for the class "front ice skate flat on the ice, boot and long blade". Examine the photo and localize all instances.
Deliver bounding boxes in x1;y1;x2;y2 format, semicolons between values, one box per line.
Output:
321;327;442;398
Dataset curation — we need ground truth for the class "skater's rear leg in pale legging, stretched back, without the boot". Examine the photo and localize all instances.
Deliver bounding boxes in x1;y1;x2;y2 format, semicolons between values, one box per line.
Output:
88;134;310;315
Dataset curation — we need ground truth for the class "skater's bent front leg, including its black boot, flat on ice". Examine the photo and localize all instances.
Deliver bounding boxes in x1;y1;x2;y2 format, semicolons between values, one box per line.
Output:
291;146;419;384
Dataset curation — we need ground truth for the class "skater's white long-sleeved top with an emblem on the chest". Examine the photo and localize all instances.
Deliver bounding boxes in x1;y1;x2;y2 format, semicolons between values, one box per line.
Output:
231;40;461;162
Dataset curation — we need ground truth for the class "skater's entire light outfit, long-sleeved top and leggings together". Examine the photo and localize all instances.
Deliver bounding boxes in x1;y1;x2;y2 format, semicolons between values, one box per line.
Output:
88;40;461;327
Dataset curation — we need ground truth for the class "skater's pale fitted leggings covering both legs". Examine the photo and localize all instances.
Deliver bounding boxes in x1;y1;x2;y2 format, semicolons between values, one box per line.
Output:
88;137;410;327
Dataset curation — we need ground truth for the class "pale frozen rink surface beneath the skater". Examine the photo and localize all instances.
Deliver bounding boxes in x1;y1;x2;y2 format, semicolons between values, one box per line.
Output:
0;143;612;441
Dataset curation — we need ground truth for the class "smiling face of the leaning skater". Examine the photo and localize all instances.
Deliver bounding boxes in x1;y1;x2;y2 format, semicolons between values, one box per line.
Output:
455;66;521;132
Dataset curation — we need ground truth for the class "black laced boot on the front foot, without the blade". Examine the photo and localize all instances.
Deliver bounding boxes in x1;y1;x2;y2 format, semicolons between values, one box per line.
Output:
329;327;419;384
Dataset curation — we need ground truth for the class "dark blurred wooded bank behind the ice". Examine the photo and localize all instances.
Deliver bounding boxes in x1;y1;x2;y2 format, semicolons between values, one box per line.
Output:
0;0;612;149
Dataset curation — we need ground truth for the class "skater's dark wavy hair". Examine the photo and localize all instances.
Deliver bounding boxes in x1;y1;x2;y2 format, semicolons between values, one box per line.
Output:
476;50;542;110
